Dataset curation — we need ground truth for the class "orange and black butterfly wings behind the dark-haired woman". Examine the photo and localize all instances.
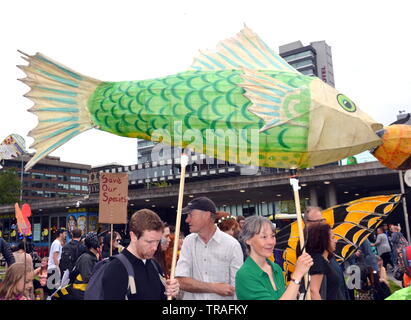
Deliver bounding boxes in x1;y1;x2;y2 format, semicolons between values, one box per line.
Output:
276;194;401;274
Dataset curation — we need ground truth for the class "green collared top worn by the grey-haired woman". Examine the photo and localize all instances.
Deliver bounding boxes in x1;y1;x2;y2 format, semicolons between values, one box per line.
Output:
235;257;285;300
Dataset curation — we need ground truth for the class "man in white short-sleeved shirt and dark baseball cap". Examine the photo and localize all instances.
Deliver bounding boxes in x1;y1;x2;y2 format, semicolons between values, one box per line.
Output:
176;197;243;300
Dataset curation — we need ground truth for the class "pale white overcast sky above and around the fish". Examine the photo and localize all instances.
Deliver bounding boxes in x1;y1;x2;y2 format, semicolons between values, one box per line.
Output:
0;0;411;166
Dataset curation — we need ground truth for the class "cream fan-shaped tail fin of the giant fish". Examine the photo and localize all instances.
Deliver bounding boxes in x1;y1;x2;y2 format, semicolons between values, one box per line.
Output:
18;51;101;170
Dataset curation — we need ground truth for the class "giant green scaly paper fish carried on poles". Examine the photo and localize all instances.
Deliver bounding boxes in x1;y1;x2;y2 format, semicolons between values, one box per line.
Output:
20;27;402;170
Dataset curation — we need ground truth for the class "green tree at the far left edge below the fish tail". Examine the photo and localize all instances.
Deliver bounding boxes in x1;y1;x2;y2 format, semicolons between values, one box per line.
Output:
0;169;21;205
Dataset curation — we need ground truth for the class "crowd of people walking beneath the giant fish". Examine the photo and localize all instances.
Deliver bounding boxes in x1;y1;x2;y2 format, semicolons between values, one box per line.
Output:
0;197;411;300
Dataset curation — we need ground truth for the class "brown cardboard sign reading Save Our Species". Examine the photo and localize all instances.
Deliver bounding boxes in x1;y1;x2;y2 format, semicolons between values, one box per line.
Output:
98;172;128;224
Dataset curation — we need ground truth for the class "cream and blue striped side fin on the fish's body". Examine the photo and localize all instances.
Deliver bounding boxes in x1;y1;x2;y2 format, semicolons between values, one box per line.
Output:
240;69;306;132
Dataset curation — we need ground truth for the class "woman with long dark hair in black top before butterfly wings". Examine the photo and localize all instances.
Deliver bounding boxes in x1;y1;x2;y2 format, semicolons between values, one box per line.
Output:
306;223;346;300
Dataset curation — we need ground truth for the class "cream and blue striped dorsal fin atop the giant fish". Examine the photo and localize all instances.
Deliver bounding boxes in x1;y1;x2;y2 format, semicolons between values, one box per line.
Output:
191;27;300;74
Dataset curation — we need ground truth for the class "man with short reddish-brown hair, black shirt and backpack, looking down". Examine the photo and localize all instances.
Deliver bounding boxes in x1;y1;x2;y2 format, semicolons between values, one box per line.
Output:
102;209;179;300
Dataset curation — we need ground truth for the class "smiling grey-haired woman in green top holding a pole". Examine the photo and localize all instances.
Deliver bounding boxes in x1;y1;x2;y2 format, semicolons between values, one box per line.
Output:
235;216;313;300
